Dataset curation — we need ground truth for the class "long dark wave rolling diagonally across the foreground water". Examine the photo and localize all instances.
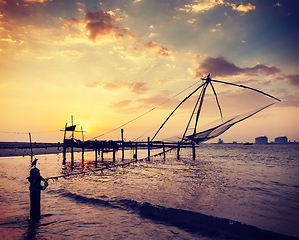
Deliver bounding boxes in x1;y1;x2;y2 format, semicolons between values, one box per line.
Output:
62;192;299;240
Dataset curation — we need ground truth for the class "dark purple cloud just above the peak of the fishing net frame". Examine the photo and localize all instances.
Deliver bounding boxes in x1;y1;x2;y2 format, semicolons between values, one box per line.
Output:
190;55;281;78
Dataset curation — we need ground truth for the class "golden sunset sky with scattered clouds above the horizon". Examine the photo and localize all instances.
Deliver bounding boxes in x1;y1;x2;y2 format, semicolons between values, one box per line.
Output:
0;0;299;142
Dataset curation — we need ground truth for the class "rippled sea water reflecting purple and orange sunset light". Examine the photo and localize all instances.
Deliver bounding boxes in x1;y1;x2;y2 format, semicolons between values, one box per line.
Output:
0;144;299;239
